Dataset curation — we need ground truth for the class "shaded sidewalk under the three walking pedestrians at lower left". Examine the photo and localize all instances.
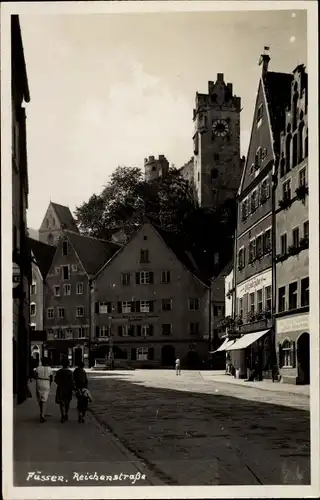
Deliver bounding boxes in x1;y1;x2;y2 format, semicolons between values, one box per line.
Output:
13;383;163;486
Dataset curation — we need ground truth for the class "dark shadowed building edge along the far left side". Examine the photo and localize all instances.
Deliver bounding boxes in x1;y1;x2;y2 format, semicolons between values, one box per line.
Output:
11;15;31;404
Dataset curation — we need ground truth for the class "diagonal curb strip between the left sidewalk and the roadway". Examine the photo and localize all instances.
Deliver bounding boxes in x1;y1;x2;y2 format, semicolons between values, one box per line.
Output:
88;408;166;486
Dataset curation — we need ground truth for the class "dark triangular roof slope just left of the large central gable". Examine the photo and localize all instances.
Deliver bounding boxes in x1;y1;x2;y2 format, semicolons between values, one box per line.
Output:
64;231;121;276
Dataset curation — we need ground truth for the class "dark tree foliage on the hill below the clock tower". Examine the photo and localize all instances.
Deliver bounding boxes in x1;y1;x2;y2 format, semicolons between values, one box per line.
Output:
75;166;236;278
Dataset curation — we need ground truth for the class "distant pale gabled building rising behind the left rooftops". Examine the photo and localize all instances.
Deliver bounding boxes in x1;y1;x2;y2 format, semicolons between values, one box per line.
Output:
39;201;79;245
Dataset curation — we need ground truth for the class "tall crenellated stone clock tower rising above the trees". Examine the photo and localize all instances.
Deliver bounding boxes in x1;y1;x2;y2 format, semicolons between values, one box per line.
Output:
193;73;243;210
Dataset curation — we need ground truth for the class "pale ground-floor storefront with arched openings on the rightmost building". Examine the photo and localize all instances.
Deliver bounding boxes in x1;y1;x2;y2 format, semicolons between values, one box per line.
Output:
276;312;310;384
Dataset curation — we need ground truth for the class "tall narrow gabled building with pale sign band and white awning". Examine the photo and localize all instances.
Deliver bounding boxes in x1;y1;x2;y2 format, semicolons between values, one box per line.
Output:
228;54;292;377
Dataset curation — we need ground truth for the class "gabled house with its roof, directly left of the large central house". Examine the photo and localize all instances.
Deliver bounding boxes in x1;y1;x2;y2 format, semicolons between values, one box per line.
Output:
44;231;119;366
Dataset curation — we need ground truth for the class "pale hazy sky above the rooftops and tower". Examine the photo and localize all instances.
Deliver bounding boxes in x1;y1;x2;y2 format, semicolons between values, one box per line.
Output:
20;11;307;229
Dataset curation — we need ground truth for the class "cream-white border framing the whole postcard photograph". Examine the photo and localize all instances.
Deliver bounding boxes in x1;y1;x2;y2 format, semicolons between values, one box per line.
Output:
1;0;320;500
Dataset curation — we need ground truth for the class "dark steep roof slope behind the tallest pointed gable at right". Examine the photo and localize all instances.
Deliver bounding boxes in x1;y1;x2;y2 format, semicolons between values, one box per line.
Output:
262;71;293;153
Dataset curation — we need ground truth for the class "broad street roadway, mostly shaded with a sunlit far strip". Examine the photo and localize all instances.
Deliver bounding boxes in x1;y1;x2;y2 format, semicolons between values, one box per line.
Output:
85;370;310;485
